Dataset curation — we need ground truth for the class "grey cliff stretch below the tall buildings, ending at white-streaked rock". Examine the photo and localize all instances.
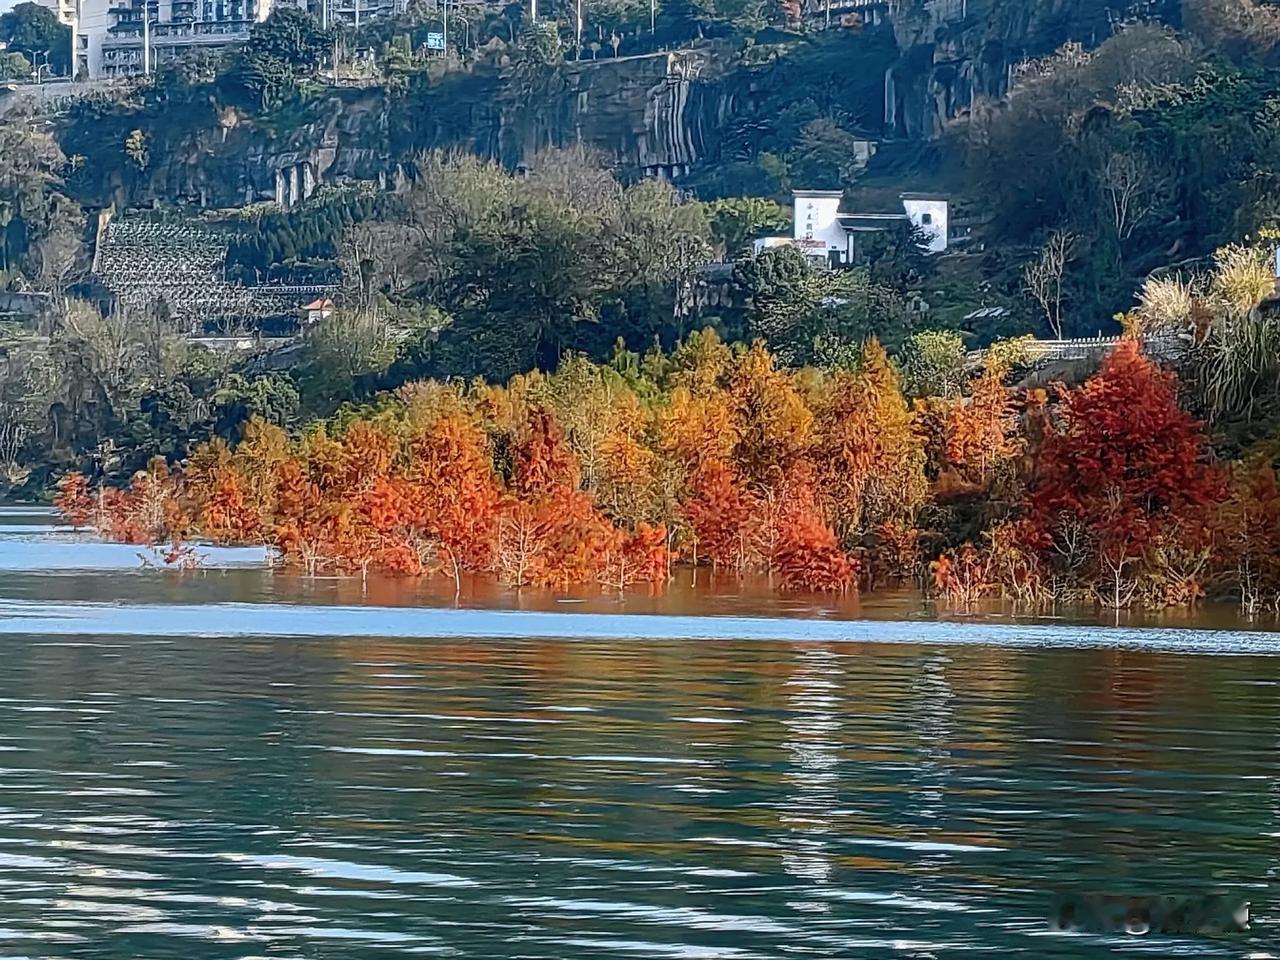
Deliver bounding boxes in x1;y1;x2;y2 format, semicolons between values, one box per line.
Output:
64;51;728;206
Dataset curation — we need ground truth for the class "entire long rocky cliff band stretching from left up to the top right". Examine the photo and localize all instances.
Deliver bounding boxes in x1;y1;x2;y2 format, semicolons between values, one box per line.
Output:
64;0;1178;206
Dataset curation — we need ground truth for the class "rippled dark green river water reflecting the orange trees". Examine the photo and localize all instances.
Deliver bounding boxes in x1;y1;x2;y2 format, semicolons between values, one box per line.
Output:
0;508;1280;960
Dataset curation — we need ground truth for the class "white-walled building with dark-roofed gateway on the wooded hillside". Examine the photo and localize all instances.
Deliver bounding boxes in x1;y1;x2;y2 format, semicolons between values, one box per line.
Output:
755;189;950;264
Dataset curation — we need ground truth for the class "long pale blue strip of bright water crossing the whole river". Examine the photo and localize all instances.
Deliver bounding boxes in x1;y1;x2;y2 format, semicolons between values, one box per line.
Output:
0;599;1280;655
